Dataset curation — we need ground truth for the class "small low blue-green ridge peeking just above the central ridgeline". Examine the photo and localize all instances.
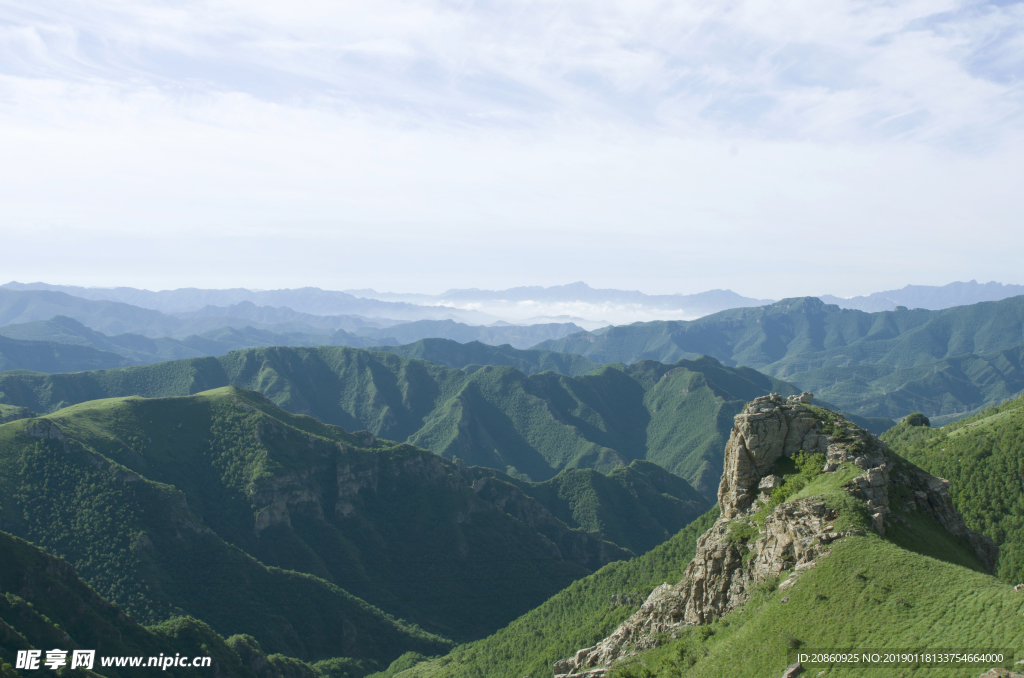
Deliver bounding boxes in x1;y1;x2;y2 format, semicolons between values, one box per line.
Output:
368;339;600;377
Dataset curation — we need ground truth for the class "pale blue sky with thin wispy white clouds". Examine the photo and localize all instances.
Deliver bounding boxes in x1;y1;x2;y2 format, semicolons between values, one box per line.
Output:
0;0;1024;298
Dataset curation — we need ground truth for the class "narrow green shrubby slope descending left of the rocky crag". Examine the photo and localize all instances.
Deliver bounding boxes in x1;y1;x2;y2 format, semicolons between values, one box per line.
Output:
372;508;718;678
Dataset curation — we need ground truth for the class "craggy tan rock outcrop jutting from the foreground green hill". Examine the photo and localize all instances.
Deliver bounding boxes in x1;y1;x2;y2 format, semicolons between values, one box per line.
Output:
554;393;995;678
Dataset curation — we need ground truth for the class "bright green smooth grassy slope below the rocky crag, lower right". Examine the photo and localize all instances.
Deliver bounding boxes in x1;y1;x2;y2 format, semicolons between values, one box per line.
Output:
608;532;1024;678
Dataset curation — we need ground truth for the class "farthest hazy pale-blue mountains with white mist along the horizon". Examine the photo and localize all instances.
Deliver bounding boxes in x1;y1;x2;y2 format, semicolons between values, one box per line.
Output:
9;281;1024;329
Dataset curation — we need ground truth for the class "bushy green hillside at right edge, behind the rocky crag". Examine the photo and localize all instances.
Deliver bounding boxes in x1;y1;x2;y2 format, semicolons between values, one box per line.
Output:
883;398;1024;584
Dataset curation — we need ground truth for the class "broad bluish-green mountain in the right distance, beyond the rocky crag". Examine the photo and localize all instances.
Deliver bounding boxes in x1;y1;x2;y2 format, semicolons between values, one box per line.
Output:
535;297;1024;417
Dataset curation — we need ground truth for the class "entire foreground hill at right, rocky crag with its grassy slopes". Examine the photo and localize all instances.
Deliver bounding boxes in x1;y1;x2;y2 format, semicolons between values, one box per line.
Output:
407;398;1024;678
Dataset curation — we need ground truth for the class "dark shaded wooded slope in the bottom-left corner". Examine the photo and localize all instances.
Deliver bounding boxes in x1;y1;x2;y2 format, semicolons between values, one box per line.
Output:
0;532;323;678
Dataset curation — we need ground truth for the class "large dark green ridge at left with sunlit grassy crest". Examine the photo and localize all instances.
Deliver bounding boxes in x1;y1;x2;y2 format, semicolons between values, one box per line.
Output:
0;387;707;661
